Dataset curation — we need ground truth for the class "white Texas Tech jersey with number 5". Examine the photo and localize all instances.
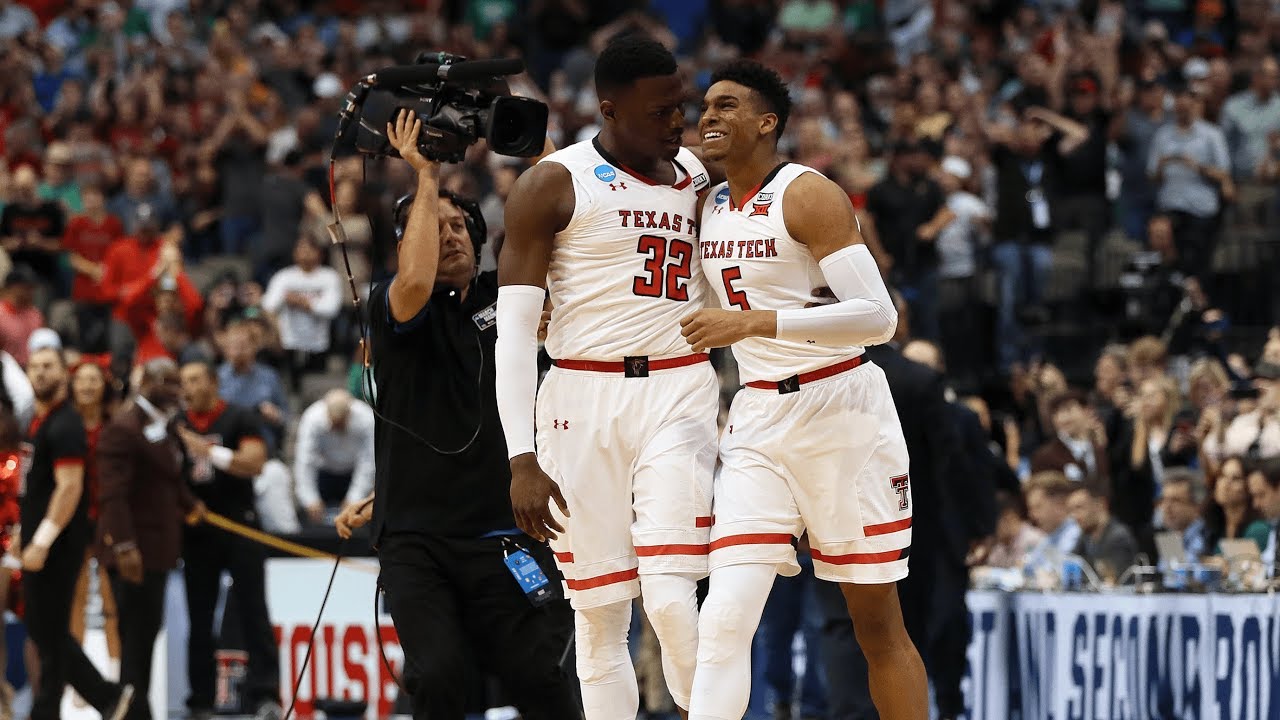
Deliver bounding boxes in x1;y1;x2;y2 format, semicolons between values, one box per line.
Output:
700;163;863;382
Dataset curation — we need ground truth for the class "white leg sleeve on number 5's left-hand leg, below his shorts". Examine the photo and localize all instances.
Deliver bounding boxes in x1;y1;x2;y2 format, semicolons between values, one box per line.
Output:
689;564;777;720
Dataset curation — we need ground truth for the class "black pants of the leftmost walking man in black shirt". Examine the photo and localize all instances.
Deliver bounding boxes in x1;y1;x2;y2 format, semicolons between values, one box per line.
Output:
23;528;121;720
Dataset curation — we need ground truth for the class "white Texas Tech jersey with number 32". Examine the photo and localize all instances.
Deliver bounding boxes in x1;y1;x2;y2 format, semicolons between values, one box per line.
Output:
541;140;708;361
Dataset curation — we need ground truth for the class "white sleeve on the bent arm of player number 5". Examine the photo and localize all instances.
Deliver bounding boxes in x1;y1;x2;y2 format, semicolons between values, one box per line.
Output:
778;245;897;345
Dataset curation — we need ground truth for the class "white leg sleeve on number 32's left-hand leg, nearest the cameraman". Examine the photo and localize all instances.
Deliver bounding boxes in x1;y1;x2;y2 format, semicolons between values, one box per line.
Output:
573;600;640;720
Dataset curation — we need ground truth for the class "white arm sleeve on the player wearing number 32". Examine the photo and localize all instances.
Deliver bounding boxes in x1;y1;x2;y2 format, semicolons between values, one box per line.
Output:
494;284;547;457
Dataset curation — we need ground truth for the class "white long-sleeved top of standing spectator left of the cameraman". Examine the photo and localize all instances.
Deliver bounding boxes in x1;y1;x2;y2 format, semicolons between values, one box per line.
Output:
262;258;342;352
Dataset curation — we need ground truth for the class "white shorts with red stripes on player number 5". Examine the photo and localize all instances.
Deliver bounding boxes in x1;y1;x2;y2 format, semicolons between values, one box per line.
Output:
710;359;911;584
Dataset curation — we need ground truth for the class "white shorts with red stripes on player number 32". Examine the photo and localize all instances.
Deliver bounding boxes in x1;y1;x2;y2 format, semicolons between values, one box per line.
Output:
536;355;719;609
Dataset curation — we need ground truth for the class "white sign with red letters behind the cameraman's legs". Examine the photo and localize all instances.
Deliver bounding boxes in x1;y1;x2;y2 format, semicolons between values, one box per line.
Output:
266;559;403;717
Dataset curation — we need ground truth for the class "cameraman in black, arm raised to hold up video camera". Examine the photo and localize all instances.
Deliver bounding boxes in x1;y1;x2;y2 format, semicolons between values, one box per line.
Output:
360;111;581;720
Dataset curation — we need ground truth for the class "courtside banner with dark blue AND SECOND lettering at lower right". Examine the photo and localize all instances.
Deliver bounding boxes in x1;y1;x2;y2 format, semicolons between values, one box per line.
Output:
965;592;1280;720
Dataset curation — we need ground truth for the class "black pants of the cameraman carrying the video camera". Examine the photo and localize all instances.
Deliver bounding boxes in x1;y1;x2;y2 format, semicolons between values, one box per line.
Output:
378;533;581;720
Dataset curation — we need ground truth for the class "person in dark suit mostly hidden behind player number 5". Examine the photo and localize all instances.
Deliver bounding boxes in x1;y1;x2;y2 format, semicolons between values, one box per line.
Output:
818;340;969;720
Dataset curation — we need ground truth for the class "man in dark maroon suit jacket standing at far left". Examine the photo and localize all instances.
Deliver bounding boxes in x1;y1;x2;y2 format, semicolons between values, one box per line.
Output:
97;359;204;720
